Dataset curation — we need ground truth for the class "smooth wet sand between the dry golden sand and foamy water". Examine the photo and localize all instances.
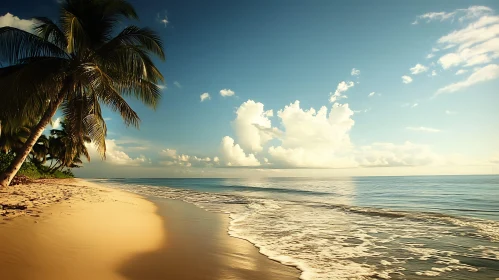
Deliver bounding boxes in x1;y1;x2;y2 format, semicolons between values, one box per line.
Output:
120;199;300;280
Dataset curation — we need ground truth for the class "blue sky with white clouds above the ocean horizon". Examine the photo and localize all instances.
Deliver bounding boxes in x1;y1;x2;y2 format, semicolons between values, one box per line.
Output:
0;0;499;177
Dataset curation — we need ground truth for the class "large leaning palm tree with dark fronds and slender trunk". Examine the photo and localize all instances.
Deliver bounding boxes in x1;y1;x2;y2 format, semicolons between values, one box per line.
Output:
0;0;165;186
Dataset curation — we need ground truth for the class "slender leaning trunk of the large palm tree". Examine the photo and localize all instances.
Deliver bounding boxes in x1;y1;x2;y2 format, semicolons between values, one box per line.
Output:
0;91;65;188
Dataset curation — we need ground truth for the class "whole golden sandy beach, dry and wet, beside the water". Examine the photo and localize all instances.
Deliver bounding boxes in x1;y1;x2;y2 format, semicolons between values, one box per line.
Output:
0;179;299;280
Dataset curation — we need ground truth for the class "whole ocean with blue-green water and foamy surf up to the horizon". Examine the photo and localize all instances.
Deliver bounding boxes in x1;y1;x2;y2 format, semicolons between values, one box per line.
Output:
93;175;499;280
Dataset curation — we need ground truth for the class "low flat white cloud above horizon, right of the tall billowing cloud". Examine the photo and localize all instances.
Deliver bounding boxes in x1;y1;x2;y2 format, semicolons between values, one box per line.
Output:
356;142;438;167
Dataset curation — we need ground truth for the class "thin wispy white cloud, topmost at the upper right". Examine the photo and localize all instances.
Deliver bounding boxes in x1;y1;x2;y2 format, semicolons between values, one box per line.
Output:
412;6;493;24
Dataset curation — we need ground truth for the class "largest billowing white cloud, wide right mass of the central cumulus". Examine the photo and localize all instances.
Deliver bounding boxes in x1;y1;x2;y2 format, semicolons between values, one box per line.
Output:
268;101;356;168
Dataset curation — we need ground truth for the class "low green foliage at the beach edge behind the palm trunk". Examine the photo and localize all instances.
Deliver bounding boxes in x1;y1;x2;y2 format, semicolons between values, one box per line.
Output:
0;153;74;179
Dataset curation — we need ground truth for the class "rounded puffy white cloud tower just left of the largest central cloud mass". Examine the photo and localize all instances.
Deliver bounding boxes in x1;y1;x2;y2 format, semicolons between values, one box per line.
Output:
232;100;280;152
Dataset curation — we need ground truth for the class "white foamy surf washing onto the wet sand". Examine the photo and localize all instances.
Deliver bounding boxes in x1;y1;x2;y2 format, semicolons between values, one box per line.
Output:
100;183;497;280
